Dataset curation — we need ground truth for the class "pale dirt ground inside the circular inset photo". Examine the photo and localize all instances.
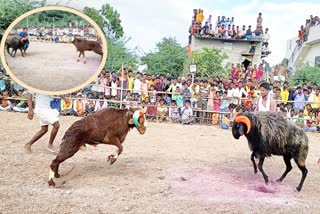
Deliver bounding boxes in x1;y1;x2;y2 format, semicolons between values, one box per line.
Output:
6;42;101;91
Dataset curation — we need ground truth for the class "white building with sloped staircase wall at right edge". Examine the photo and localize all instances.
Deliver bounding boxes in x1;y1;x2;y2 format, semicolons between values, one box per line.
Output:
286;25;320;68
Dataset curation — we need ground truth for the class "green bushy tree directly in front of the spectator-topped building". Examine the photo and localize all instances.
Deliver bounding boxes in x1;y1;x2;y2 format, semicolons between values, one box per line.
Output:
187;48;229;78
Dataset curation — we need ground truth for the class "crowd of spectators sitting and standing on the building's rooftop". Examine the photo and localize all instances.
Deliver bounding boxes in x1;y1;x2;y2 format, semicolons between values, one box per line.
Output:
189;9;271;55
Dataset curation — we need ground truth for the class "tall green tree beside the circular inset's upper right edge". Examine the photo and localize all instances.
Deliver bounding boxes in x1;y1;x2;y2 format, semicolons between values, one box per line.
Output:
83;4;124;39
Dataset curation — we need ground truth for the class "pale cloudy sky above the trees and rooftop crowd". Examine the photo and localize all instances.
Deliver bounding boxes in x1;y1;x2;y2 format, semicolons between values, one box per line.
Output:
47;0;320;64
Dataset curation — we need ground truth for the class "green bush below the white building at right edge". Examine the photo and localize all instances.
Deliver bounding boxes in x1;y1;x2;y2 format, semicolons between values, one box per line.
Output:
291;65;320;86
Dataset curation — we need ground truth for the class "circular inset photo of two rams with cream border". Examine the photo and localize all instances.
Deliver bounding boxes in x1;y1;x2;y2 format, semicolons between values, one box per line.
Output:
1;6;107;95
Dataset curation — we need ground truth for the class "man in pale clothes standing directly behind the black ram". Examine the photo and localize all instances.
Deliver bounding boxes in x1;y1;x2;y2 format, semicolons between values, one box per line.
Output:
255;82;277;112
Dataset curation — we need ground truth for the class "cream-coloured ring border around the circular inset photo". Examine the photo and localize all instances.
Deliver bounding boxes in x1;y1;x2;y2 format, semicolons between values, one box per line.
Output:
0;6;108;95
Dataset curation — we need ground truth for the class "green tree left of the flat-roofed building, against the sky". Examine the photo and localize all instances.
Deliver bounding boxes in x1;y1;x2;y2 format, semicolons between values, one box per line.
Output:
141;38;187;76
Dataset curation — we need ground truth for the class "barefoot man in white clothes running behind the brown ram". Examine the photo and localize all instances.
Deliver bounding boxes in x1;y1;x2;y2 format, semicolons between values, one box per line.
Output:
25;92;60;154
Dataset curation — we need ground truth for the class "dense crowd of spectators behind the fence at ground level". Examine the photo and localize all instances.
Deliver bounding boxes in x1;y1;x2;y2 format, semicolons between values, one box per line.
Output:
0;64;320;131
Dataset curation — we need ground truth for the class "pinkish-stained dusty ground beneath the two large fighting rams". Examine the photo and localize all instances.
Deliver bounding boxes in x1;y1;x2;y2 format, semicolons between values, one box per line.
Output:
0;112;320;214
